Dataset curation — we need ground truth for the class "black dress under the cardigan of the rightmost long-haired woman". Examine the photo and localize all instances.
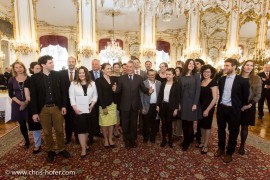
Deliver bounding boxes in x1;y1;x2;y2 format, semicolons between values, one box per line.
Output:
240;78;256;126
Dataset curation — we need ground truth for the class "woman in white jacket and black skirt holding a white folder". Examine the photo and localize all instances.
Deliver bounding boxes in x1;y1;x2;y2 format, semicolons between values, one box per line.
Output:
69;66;98;158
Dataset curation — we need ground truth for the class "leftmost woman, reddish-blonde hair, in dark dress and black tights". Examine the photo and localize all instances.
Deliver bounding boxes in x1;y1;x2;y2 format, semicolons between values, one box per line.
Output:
8;61;30;149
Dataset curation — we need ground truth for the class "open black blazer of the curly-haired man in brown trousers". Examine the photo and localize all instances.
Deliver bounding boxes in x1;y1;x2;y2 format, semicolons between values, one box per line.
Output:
30;71;67;114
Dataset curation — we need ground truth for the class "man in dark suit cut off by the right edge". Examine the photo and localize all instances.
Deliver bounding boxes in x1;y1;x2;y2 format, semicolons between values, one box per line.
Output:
258;64;270;119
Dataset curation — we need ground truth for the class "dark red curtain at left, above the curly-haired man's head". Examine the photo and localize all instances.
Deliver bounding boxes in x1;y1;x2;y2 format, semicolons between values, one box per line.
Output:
39;35;68;51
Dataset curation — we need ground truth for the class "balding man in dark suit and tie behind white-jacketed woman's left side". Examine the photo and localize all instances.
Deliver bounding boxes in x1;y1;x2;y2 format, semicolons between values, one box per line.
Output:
60;56;79;144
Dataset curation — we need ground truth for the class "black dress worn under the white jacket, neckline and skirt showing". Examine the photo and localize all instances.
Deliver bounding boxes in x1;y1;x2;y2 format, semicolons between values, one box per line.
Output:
74;85;93;134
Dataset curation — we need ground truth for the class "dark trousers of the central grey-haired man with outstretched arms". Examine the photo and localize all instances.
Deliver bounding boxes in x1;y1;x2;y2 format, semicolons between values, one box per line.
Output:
121;108;138;143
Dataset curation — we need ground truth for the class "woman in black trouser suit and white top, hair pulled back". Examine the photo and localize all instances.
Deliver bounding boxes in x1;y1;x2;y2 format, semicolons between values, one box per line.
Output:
157;68;179;148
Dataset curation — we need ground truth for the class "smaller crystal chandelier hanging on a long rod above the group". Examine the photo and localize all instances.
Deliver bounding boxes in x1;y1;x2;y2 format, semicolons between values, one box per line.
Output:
101;11;125;61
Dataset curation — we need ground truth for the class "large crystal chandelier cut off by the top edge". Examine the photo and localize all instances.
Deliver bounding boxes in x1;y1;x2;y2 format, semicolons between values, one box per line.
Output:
113;0;187;22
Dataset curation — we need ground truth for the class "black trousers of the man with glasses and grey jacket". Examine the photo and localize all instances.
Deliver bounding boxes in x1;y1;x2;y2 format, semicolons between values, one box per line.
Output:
142;104;157;140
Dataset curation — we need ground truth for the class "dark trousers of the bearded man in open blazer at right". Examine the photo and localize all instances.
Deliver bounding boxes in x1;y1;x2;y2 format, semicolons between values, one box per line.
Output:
217;105;241;155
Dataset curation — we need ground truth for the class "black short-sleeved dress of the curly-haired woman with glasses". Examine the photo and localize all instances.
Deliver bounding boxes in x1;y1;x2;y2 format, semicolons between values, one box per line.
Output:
198;80;217;129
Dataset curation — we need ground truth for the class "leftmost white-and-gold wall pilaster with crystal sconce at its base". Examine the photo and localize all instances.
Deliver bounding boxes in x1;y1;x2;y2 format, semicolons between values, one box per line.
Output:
10;0;39;69
